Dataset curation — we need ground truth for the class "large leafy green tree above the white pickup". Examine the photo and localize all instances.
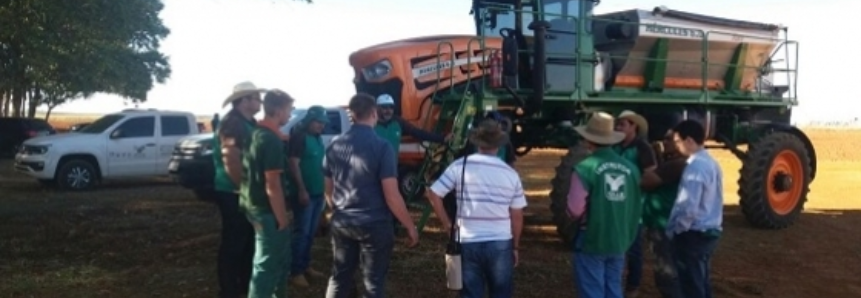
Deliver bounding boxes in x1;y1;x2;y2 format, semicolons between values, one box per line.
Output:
0;0;171;117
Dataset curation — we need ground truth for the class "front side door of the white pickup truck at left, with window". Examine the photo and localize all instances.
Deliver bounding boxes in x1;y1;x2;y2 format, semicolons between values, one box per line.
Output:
107;116;158;177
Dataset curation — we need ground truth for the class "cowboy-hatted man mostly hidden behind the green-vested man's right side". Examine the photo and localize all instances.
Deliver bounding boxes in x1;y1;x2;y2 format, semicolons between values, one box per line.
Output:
613;110;657;298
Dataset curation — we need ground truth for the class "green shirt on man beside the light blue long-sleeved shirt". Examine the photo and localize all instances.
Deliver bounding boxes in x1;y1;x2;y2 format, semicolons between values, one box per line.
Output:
643;158;687;230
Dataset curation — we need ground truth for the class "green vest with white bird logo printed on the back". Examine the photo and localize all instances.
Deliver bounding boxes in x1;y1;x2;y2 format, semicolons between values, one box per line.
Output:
574;148;643;254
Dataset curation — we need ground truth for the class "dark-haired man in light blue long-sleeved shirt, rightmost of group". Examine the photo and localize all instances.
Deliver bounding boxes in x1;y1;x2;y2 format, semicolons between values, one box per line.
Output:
666;120;723;298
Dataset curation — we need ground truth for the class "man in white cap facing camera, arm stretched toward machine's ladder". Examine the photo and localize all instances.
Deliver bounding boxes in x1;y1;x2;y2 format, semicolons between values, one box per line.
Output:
374;94;451;163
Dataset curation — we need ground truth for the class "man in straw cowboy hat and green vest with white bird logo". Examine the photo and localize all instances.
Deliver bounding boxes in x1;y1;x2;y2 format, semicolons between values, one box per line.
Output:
568;112;642;298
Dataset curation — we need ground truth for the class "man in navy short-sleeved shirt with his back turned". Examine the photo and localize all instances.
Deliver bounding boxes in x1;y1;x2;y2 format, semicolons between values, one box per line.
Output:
323;94;419;298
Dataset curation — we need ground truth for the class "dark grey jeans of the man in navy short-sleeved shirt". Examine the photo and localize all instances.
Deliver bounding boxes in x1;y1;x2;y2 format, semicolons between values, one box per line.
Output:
326;221;395;298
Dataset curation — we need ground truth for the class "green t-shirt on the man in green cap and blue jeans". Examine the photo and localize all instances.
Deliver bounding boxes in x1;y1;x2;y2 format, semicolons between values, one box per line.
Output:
289;131;326;196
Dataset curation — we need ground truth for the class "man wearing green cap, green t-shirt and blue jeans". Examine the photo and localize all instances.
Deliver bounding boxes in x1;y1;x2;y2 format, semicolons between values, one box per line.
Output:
288;106;329;287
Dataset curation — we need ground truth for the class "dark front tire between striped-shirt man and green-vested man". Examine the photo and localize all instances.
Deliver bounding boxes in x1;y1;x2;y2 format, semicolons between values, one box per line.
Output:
550;145;589;245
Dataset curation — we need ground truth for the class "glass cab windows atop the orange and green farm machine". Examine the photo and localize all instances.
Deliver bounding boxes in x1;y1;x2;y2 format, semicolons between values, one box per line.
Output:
473;0;580;37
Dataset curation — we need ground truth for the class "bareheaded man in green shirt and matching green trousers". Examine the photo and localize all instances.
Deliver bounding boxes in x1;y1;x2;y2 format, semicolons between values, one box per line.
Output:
239;90;293;298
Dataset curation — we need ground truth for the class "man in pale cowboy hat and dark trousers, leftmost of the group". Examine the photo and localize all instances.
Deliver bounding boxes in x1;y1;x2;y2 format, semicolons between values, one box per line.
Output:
212;82;264;297
